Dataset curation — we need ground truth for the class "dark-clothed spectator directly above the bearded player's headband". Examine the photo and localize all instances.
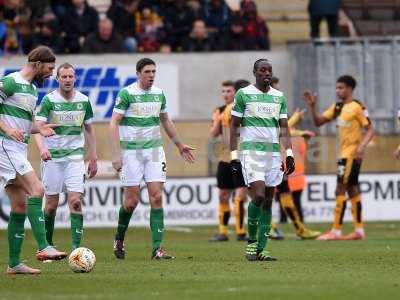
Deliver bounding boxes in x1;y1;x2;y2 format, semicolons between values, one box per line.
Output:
32;13;64;53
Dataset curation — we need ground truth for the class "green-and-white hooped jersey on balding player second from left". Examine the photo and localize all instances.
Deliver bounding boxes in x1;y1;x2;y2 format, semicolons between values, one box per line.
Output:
35;90;93;161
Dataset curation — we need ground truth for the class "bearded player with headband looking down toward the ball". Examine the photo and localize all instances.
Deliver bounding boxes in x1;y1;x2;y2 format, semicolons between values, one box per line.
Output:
0;46;67;274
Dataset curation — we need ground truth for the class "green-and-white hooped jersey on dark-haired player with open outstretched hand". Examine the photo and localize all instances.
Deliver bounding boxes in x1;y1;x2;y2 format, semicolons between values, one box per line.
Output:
114;82;166;151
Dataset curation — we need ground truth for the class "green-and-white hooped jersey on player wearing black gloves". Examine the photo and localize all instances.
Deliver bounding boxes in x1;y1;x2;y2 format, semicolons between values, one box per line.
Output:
231;84;287;156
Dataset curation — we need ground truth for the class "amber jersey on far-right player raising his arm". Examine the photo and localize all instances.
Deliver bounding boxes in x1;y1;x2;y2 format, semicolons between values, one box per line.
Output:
323;100;371;158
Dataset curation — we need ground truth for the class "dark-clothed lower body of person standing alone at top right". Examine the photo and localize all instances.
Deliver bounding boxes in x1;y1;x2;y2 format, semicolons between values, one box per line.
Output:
308;0;341;39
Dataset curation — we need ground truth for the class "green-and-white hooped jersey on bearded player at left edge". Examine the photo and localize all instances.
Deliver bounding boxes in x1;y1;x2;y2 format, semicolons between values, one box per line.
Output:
0;72;38;146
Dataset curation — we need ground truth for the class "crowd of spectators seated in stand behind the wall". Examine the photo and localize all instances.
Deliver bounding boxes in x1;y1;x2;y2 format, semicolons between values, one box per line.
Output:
0;0;270;55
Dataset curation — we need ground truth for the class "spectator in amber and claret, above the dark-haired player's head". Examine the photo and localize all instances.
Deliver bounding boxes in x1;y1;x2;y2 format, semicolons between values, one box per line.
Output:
136;7;163;52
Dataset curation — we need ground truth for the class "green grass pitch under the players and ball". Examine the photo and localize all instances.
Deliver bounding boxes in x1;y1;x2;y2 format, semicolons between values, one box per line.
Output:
0;222;400;300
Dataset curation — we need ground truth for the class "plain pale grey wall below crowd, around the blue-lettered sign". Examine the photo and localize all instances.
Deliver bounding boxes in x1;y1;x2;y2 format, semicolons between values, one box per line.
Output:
0;48;292;120
